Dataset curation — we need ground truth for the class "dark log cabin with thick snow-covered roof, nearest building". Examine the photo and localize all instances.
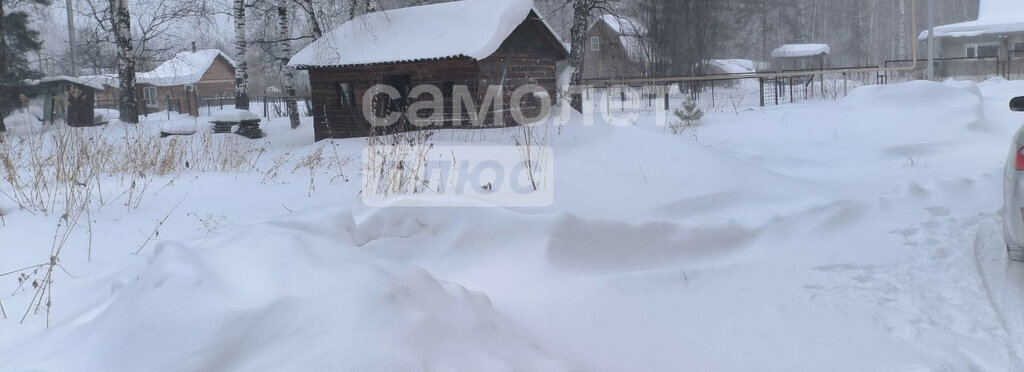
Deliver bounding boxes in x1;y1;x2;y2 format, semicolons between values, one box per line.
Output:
289;0;568;140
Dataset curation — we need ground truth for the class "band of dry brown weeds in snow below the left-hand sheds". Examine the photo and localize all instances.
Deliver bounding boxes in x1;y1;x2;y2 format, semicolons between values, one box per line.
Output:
0;126;264;215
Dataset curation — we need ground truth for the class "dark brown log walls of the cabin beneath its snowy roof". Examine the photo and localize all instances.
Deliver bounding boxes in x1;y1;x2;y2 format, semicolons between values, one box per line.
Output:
309;12;566;140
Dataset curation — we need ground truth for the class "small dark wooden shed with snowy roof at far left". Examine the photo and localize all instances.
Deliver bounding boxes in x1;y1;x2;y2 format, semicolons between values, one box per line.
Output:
35;76;103;127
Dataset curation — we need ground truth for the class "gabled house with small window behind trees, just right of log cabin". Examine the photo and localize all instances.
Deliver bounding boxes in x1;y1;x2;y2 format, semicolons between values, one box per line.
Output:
583;14;647;79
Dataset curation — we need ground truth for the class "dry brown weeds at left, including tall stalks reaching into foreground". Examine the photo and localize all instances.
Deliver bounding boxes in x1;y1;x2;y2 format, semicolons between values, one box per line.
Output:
0;125;265;326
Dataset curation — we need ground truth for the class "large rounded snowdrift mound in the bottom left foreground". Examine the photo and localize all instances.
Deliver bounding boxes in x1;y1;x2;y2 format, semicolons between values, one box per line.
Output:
0;212;568;371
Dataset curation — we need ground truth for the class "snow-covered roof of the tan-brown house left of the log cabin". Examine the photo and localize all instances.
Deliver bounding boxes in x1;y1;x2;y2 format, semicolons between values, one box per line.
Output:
136;49;236;86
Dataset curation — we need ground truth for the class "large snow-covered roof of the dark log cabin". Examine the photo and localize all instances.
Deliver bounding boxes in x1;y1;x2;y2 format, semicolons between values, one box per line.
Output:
288;0;567;67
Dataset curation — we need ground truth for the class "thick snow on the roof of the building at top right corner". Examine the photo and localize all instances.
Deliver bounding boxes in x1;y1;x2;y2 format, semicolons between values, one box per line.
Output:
918;0;1024;40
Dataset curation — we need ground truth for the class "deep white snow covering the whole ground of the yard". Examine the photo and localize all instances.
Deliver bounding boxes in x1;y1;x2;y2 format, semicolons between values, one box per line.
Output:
0;80;1024;371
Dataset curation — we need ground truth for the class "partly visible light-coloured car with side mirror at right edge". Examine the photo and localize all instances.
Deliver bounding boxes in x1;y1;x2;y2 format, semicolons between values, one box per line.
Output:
1002;96;1024;261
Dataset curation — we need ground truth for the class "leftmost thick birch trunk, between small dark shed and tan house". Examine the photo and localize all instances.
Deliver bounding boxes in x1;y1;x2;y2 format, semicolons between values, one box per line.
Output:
111;0;138;124
